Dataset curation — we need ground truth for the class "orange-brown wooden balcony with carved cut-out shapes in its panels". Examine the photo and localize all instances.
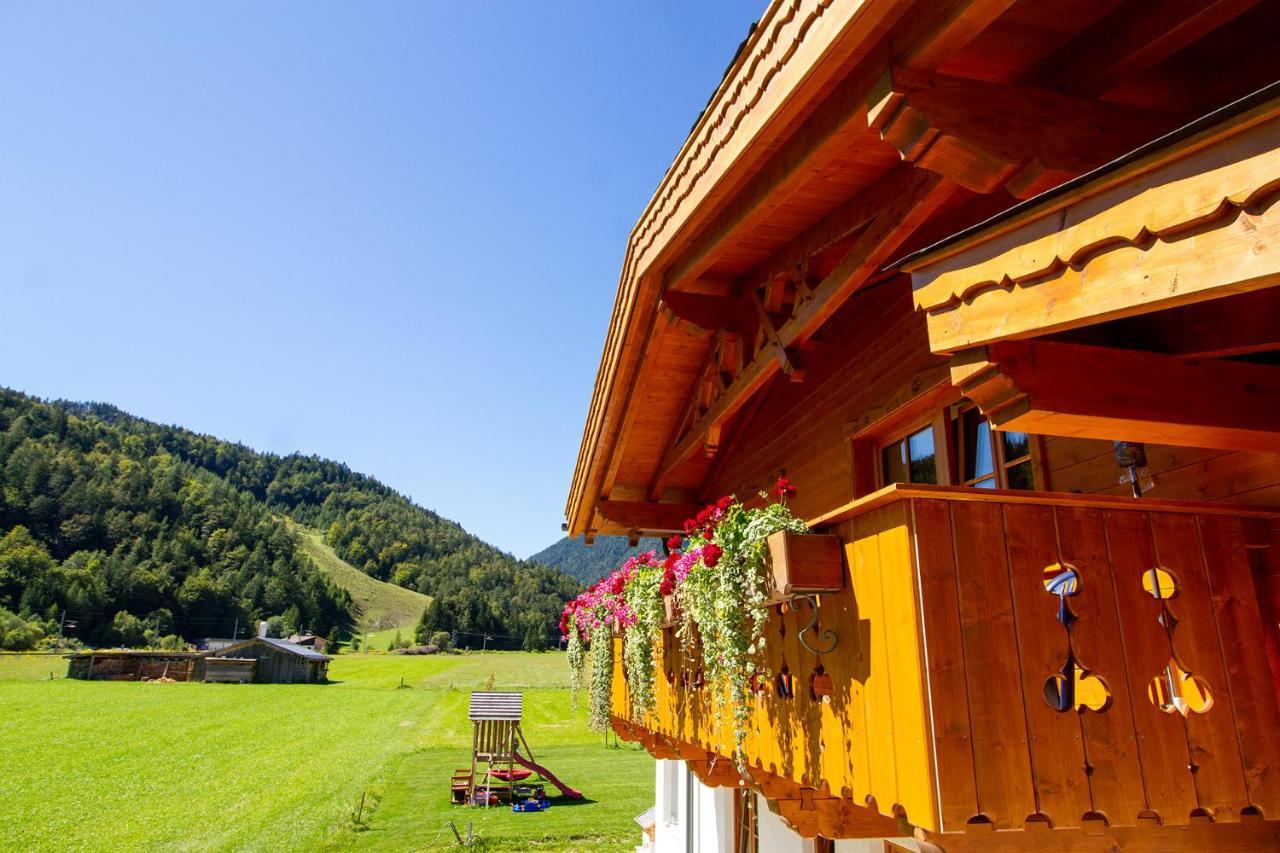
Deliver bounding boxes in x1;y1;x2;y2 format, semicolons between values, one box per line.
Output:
613;487;1280;849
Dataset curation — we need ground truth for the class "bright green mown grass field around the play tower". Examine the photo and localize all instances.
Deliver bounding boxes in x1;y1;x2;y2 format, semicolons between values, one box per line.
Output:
0;652;653;850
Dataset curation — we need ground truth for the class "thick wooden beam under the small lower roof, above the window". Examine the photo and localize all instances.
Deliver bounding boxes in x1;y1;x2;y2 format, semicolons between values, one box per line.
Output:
951;341;1280;453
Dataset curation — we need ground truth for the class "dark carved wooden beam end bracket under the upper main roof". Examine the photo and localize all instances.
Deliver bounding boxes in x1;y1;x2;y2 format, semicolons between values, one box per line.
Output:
867;68;1176;199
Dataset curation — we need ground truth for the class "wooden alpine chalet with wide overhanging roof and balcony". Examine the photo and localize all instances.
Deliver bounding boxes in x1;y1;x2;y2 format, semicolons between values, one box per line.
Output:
567;0;1280;853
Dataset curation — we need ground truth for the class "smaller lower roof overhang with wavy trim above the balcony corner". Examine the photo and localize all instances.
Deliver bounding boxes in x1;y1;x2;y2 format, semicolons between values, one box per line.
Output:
904;83;1280;452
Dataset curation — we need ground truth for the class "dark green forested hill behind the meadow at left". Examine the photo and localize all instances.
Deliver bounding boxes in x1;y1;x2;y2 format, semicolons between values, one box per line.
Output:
0;389;579;647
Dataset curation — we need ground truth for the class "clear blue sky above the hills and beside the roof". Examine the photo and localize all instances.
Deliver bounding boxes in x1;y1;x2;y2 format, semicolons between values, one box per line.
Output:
0;0;764;556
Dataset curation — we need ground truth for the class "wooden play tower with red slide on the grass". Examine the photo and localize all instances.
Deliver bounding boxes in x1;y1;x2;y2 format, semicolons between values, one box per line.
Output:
449;693;582;812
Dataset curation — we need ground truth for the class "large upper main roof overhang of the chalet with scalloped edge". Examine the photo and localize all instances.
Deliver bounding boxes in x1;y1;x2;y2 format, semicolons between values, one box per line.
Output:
566;0;1280;538
